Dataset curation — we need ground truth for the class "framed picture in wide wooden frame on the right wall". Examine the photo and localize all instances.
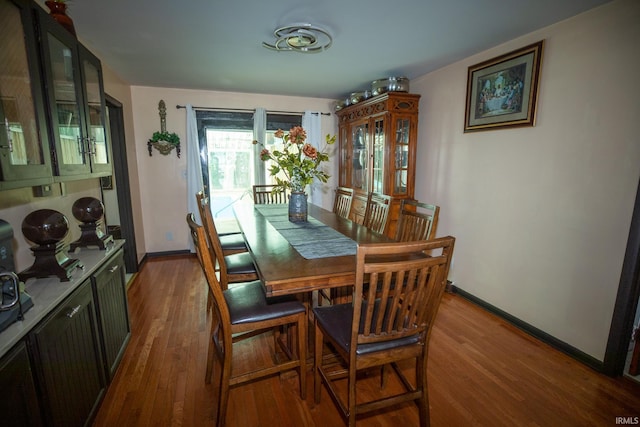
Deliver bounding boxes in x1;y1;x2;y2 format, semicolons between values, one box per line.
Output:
464;40;544;132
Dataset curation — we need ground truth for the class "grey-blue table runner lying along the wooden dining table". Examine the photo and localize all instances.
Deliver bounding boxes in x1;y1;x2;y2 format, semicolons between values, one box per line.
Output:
255;205;357;259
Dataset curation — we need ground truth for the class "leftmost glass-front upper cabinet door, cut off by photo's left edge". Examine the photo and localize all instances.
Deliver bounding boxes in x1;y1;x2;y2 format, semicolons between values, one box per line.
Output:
0;0;52;189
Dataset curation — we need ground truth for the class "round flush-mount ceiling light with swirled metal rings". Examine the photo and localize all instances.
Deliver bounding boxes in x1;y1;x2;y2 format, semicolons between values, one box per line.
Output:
262;24;333;53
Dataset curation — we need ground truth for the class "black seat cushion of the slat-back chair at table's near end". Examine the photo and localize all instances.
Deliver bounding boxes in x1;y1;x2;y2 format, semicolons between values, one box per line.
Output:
313;303;420;355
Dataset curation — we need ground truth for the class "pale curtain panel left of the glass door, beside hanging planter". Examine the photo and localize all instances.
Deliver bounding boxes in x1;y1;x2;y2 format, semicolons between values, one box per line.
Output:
186;104;204;252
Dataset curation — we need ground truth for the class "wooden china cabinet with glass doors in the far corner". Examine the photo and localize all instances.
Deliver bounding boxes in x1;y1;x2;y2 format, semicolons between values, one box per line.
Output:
336;92;420;237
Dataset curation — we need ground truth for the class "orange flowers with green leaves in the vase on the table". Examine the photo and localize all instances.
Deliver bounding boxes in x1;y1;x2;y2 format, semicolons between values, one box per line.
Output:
253;126;336;193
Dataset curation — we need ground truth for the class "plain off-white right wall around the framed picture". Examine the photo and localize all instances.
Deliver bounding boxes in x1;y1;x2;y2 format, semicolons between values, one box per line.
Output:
411;0;640;360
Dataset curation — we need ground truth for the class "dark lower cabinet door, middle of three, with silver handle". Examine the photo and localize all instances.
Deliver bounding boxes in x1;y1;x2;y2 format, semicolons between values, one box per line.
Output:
31;281;105;426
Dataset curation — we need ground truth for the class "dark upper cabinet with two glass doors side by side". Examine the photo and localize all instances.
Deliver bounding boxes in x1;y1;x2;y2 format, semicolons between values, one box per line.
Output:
39;11;111;180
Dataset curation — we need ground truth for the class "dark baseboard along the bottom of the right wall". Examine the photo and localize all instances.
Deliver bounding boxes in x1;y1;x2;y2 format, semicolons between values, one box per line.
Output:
449;284;605;373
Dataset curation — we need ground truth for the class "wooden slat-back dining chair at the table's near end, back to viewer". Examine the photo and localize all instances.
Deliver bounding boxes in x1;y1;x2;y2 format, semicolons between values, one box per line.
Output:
313;236;455;427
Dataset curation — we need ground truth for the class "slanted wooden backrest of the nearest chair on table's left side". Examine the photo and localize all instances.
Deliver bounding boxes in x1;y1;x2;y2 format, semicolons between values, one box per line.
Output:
187;213;232;342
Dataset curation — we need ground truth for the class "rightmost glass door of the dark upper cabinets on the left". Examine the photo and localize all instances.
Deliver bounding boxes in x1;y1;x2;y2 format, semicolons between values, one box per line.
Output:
80;46;111;173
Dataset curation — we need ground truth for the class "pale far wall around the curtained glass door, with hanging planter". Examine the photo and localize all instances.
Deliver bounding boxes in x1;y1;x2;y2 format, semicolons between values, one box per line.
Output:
131;86;337;252
